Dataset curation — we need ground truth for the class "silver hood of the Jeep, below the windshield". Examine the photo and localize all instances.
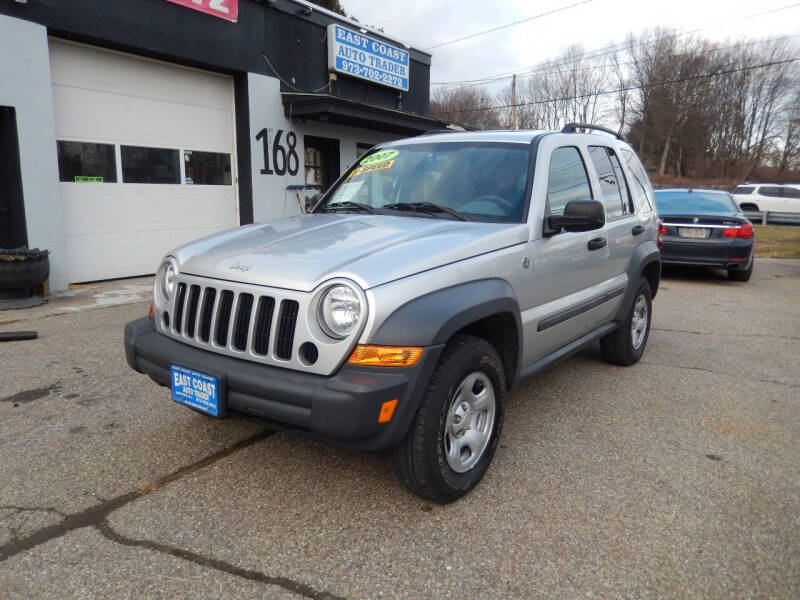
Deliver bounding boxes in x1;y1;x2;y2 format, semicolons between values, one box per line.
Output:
171;214;528;291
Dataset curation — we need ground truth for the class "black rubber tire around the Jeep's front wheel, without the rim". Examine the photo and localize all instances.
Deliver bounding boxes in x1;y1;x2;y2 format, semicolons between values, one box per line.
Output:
392;335;506;504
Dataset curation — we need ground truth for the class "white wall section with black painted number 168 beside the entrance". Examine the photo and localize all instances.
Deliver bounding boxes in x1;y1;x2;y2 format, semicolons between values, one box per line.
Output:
247;73;401;221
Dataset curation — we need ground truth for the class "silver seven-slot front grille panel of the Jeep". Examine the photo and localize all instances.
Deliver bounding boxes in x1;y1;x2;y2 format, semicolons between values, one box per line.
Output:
155;273;358;375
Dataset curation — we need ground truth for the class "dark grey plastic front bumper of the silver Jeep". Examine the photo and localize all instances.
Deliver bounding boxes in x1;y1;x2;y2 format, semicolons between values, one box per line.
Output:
125;317;443;450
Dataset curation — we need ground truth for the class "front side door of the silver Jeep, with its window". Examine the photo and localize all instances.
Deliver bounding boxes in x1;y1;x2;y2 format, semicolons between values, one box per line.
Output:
522;141;606;363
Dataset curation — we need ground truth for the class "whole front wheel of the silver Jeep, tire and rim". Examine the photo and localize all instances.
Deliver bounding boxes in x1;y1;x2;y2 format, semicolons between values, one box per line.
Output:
392;335;505;504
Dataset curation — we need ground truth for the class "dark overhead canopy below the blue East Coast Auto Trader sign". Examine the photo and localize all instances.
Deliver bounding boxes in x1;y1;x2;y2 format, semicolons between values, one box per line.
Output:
281;92;447;135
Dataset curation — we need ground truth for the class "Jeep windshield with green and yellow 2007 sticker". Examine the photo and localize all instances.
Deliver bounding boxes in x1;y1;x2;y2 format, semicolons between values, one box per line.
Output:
314;142;530;223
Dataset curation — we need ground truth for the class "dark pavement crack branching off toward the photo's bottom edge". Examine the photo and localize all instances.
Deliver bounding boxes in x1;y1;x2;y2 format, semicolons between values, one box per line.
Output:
94;519;342;600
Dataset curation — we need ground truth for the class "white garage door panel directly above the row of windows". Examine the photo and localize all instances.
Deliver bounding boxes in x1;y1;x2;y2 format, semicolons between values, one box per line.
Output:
53;86;233;150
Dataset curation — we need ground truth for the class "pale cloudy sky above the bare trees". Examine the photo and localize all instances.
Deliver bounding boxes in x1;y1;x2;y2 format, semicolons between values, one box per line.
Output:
340;0;800;91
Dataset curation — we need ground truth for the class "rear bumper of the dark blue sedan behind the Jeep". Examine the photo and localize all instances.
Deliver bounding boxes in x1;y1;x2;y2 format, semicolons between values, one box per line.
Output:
661;236;753;269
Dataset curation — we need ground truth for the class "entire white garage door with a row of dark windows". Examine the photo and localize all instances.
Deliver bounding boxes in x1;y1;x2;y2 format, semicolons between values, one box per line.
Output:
50;38;237;282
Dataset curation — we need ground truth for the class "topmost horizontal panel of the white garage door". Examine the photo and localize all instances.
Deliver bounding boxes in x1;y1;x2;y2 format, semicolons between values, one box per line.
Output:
50;38;231;110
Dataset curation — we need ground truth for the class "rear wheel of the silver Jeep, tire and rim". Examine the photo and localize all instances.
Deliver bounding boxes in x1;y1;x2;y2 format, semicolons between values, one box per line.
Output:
600;280;653;367
